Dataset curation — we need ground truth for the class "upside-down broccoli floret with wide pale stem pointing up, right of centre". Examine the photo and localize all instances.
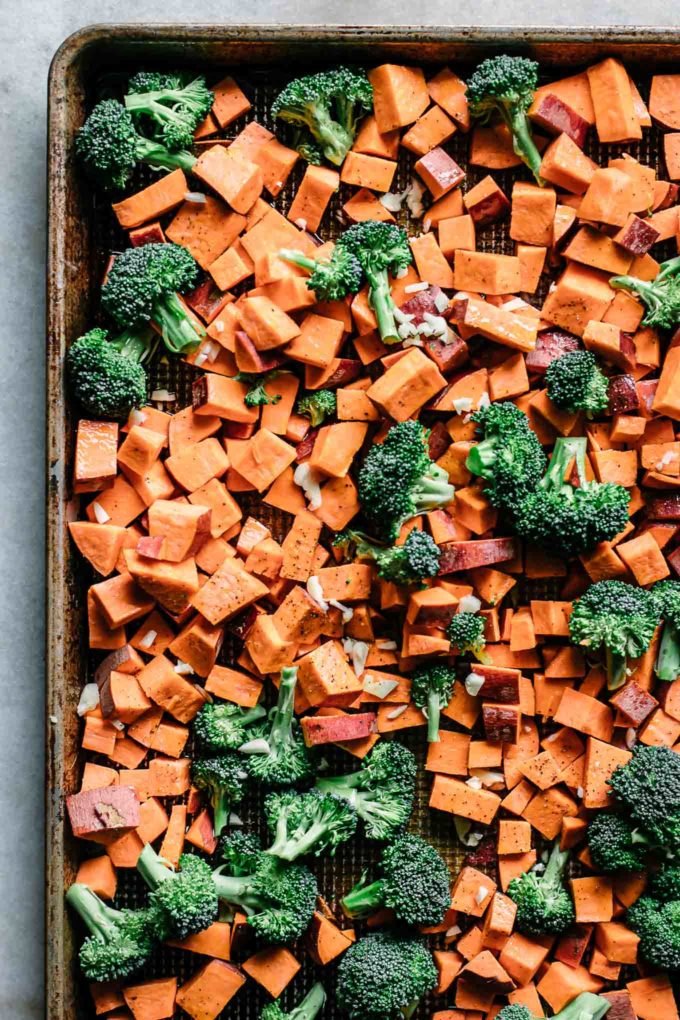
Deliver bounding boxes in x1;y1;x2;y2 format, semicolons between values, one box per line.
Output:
514;437;630;559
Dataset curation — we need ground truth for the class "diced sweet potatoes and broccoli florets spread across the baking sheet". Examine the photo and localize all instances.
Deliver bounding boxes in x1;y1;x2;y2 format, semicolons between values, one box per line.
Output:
66;56;680;1020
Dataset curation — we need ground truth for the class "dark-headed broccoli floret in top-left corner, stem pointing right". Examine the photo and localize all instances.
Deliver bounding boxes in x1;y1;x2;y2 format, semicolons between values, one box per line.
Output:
75;99;196;191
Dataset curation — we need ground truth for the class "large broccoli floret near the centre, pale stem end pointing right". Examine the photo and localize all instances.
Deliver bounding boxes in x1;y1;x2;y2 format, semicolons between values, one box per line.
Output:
359;420;454;542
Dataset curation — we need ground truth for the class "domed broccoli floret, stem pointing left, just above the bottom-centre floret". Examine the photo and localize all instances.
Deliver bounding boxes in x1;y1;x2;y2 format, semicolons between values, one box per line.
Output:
342;832;451;926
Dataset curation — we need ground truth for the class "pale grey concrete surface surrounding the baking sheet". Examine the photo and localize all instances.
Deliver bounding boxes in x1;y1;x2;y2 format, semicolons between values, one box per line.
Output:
0;0;680;1020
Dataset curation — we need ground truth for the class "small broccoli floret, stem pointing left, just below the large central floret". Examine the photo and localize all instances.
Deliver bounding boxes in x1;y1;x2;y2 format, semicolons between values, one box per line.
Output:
333;527;439;588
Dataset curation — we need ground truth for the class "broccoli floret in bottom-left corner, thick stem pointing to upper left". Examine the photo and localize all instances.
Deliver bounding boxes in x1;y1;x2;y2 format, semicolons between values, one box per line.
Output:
66;882;154;981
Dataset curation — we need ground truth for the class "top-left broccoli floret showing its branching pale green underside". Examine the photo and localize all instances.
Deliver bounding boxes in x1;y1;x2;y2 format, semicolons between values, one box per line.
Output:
124;71;215;151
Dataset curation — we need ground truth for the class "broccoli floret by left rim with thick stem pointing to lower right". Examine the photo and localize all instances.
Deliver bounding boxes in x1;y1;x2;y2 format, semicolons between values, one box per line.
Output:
102;244;205;354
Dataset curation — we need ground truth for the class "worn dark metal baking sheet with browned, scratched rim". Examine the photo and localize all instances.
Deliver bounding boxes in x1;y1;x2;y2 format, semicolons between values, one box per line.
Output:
50;24;680;1020
